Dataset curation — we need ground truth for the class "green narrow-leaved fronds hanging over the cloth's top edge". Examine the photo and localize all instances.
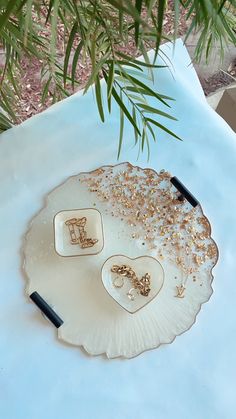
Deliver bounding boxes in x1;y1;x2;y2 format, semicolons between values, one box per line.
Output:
0;0;236;155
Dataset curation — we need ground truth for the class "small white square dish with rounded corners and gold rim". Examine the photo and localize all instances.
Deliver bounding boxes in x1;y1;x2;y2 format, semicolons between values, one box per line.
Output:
54;208;104;257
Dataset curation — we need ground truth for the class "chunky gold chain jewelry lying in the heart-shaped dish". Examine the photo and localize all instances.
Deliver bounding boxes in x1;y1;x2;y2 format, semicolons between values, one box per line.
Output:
111;265;151;297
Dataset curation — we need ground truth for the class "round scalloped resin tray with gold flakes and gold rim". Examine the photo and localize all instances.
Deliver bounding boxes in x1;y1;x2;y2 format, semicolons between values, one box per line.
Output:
23;163;218;358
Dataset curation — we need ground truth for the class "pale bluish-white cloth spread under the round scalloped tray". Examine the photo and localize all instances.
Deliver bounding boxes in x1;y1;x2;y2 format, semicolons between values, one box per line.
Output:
0;40;236;419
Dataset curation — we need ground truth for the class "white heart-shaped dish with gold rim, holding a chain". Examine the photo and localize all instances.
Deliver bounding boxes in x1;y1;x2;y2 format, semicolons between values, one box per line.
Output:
102;255;164;313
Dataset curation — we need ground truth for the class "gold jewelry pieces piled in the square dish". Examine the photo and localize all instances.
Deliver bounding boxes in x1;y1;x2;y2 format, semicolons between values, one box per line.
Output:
65;217;98;249
